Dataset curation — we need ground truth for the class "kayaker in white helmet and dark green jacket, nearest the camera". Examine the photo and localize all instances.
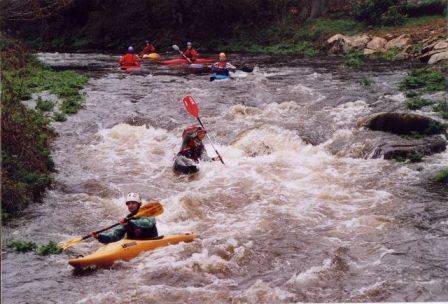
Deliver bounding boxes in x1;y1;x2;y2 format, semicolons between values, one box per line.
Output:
92;192;158;244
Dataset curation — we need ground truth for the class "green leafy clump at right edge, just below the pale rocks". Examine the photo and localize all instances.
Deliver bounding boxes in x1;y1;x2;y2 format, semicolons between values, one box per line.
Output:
400;68;446;92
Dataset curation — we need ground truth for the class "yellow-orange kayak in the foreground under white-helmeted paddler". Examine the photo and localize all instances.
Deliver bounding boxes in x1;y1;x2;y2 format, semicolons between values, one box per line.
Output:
68;233;196;268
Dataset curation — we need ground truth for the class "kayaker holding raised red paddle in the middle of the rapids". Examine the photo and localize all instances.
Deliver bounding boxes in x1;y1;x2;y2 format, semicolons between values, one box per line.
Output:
174;125;219;174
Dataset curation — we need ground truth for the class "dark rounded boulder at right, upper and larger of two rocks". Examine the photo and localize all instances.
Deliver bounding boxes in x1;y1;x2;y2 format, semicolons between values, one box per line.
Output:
357;112;445;135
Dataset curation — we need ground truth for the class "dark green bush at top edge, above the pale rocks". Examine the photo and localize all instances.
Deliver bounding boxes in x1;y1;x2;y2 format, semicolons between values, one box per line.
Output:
352;0;406;25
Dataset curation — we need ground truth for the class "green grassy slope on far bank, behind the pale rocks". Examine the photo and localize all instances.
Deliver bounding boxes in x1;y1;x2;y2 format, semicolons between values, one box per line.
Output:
212;16;445;59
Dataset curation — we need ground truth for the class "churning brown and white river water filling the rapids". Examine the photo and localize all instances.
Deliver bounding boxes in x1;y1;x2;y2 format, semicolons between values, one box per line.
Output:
2;53;448;303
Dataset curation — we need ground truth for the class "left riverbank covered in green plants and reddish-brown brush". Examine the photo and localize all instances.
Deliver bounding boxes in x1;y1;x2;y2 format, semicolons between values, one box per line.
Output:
1;39;88;219
